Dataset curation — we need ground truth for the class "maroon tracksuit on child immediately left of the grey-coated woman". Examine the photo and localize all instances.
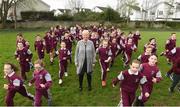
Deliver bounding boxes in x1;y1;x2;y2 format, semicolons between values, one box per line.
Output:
58;48;70;79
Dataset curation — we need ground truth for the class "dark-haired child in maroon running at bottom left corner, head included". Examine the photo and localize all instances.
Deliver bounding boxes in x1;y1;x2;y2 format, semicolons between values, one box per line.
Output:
4;63;34;106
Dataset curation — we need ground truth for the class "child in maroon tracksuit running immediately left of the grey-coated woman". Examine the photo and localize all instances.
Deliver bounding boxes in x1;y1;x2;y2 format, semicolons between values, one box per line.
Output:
57;41;70;84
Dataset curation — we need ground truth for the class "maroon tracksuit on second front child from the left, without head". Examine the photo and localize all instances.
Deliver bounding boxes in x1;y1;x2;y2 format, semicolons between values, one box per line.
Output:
30;69;52;106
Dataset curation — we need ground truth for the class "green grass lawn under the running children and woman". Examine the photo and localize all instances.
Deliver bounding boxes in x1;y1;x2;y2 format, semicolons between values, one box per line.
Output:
0;30;180;106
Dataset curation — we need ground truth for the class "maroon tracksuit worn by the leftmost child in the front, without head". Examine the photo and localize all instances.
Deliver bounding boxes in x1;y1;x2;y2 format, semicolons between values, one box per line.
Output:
6;72;34;106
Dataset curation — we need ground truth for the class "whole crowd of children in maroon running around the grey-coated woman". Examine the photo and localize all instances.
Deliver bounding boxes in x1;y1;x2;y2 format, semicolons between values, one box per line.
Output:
4;25;180;106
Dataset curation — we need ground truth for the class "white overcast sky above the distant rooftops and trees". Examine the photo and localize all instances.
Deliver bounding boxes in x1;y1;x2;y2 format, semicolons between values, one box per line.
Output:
43;0;117;10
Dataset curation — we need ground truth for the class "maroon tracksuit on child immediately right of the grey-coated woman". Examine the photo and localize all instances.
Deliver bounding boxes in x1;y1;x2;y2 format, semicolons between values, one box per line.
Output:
97;47;112;81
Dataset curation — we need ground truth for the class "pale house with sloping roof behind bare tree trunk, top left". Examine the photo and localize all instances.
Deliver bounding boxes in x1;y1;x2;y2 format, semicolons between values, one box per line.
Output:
8;0;50;20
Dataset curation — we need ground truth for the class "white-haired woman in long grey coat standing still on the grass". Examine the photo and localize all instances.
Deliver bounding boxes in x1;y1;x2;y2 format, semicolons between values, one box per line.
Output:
75;30;96;91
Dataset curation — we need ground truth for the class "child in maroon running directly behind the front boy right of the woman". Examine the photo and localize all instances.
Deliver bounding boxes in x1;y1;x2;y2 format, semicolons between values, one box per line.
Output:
124;38;136;67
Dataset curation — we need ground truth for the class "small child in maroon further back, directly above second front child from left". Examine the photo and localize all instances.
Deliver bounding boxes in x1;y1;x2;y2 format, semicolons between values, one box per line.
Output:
34;35;45;60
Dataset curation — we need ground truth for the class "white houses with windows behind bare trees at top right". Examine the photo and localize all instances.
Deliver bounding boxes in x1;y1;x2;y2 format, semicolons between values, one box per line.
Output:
129;0;180;21
